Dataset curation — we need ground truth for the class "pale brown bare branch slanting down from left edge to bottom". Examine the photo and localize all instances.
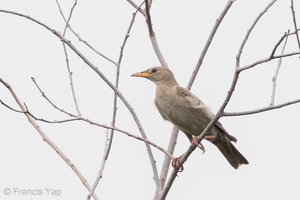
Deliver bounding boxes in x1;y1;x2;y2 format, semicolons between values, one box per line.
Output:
0;78;98;200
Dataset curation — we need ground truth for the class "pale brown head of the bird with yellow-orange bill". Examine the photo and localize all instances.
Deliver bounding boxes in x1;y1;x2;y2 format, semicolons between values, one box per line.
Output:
131;67;177;84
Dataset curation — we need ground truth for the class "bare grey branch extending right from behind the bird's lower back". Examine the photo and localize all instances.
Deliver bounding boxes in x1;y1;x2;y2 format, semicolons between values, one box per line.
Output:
222;99;300;117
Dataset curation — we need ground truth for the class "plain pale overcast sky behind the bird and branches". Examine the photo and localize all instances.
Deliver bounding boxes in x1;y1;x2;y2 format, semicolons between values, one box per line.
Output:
0;0;300;200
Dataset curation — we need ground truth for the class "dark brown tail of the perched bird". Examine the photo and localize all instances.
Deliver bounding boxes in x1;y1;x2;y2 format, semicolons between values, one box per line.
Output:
211;134;249;169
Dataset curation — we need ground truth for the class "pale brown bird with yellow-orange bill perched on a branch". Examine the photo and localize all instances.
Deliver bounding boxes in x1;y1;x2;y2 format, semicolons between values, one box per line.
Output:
131;66;249;169
